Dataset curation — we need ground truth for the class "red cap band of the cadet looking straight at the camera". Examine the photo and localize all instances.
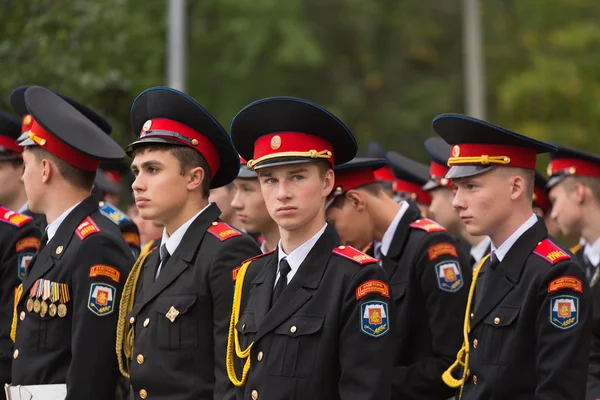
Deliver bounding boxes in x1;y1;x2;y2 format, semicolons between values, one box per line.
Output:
248;132;334;168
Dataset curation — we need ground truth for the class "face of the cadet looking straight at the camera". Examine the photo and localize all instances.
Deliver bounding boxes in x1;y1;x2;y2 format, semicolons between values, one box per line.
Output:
258;162;334;231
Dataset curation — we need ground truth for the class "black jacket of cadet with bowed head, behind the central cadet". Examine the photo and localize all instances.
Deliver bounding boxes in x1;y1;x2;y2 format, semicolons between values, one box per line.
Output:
382;204;472;400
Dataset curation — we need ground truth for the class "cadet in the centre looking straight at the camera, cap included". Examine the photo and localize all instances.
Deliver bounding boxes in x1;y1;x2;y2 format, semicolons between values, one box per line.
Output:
227;97;393;400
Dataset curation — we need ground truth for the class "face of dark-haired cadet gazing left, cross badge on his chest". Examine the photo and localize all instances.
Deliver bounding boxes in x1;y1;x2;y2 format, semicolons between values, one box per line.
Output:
131;150;189;223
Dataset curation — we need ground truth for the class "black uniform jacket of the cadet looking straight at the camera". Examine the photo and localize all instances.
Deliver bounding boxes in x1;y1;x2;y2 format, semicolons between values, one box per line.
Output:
231;225;393;400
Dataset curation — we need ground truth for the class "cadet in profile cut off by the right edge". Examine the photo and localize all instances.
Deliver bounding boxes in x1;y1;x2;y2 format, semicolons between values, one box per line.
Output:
547;146;600;400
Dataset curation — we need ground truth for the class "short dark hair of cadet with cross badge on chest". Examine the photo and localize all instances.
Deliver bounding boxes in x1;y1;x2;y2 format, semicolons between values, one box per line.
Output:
131;143;212;199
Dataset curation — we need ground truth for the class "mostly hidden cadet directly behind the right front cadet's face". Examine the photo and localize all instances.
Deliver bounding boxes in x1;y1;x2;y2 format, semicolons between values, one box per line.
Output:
423;137;491;268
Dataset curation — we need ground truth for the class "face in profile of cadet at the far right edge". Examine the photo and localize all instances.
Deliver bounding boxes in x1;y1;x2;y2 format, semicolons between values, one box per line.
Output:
549;184;585;238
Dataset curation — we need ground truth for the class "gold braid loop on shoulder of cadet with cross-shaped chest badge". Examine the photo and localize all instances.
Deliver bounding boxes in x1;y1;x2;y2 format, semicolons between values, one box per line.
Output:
116;240;154;379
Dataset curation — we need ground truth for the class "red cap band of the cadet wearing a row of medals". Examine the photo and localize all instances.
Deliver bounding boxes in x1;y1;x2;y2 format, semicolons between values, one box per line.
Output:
29;118;100;171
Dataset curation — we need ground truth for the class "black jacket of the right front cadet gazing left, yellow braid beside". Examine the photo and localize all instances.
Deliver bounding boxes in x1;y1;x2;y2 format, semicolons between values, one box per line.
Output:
463;219;592;400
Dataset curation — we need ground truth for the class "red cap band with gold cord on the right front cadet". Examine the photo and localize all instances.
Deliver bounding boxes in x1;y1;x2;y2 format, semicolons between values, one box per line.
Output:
448;144;536;169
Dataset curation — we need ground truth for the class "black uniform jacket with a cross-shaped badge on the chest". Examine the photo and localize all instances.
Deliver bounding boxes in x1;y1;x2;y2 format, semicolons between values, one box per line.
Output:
127;204;261;400
